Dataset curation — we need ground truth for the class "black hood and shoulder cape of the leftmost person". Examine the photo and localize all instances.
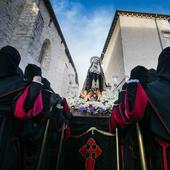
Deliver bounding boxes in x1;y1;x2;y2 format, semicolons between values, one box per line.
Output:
0;46;23;96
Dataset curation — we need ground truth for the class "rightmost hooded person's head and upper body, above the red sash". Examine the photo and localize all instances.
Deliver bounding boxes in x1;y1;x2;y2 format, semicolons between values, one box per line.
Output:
147;47;170;141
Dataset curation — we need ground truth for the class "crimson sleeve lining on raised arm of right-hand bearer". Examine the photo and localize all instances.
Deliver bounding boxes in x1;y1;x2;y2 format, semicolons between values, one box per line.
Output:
125;83;148;122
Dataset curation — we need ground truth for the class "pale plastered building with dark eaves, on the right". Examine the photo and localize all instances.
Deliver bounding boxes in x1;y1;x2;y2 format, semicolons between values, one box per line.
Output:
101;11;170;87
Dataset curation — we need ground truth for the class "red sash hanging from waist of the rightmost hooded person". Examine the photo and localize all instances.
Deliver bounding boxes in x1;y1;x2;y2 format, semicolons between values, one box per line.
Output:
155;138;170;170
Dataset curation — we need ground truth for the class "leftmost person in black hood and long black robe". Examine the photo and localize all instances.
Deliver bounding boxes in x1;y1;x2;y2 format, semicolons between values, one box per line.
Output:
0;46;25;170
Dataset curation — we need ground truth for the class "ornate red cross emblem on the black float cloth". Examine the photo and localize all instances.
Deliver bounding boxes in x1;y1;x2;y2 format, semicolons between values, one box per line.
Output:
79;138;102;170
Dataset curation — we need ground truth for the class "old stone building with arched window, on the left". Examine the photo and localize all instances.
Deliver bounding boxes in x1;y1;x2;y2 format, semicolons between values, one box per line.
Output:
0;0;78;97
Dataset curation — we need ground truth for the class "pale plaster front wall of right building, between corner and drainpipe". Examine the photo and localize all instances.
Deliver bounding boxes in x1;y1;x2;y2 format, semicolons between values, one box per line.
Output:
120;16;161;76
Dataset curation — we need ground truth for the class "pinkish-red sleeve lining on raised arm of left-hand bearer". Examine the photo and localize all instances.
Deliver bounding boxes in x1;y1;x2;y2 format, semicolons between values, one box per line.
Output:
14;86;43;119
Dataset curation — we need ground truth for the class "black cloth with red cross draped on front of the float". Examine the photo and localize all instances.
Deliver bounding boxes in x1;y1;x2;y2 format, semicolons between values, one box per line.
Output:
63;117;116;170
